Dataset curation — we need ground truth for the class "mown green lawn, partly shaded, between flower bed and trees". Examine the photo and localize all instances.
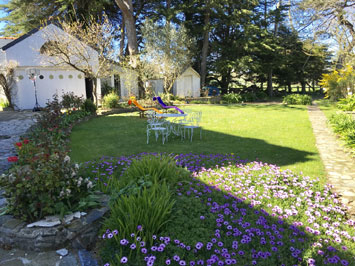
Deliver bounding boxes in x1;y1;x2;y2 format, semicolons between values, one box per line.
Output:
71;104;324;177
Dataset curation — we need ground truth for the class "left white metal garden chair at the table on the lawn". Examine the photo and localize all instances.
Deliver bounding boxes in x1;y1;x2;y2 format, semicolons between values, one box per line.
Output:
147;110;169;144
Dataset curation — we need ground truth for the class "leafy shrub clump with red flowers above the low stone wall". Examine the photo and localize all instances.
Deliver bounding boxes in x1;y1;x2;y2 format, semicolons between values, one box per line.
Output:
0;97;93;222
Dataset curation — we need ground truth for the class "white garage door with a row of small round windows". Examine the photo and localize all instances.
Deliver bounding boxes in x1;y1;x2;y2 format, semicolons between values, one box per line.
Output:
14;68;86;110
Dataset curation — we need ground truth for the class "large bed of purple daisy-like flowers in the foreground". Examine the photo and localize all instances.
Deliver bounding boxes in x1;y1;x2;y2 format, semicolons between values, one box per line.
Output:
83;154;355;265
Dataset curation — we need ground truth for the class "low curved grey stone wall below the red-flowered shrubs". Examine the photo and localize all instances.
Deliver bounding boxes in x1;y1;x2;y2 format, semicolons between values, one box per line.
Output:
0;196;109;251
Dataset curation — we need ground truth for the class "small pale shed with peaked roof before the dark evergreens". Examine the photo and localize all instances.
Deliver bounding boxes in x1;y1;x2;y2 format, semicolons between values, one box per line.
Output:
173;67;201;98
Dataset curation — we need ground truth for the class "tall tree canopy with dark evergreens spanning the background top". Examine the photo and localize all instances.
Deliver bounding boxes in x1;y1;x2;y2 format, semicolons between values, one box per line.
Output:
1;0;344;95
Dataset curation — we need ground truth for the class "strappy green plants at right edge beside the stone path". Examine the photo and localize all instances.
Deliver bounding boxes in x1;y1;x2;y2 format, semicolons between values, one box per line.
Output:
329;113;355;149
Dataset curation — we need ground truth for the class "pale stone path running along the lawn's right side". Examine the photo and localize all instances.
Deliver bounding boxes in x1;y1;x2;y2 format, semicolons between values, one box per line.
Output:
308;105;355;217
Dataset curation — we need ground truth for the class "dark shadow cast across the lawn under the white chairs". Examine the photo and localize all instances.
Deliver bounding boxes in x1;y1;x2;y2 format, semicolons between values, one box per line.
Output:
71;116;318;170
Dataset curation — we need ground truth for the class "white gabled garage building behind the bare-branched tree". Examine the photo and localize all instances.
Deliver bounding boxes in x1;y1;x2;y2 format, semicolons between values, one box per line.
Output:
0;24;101;110
